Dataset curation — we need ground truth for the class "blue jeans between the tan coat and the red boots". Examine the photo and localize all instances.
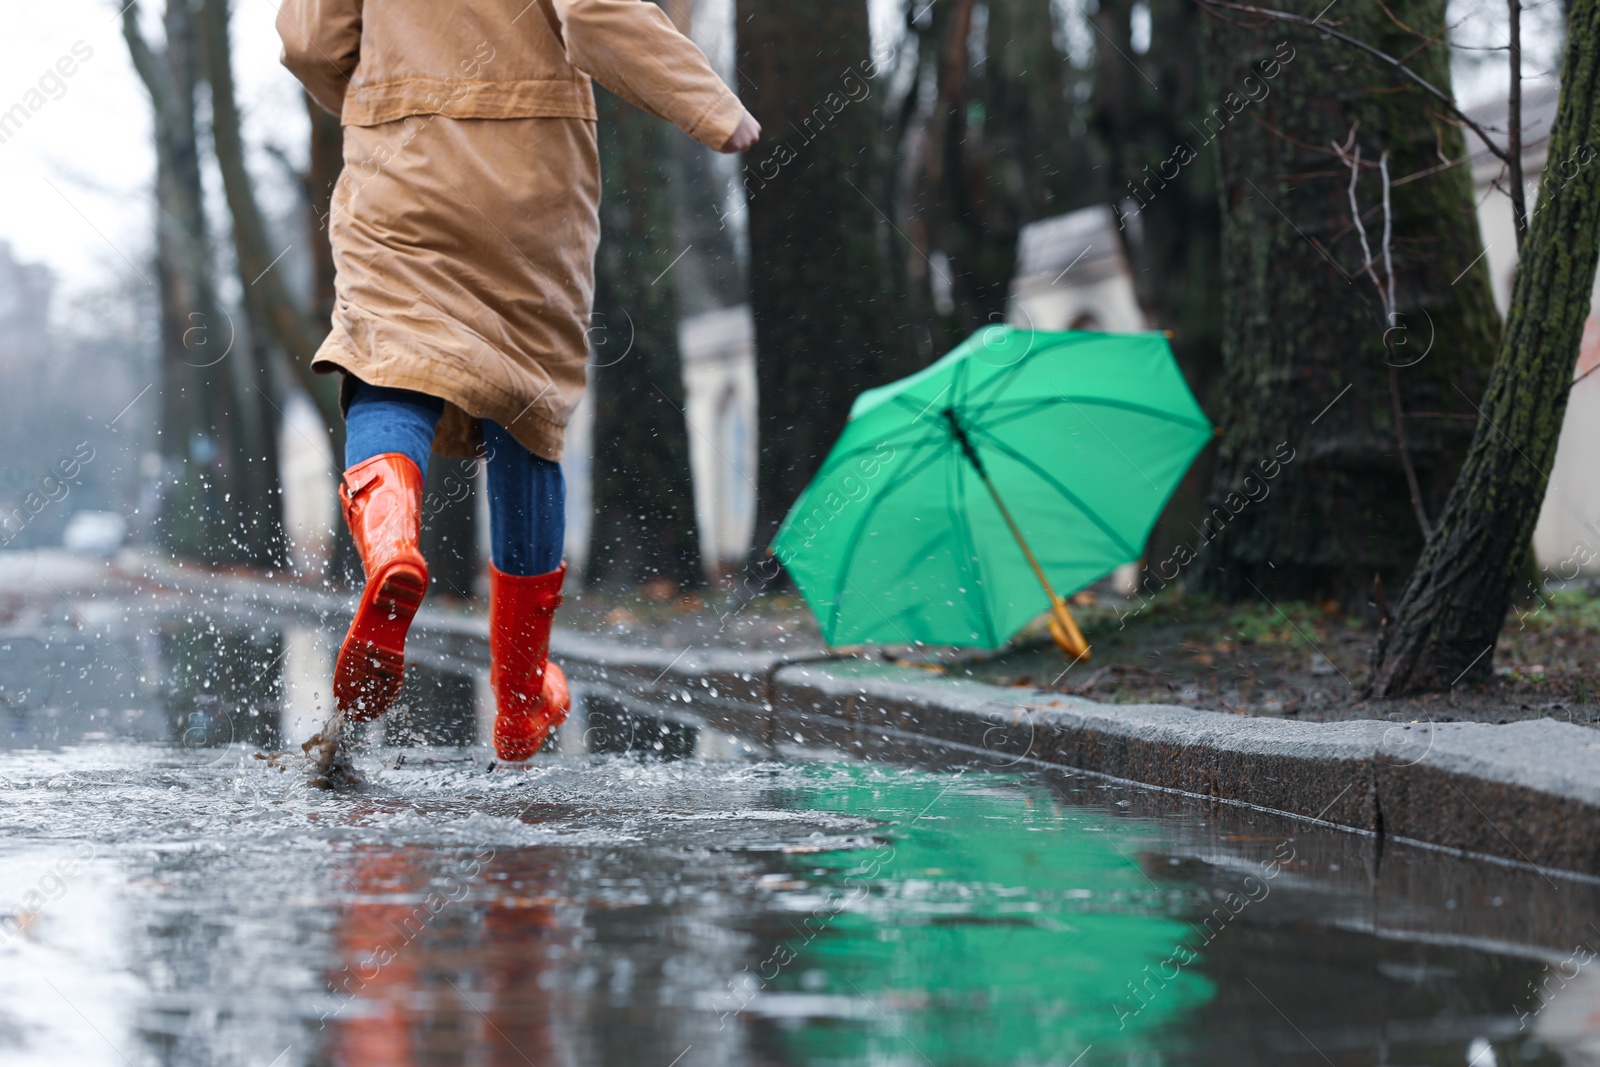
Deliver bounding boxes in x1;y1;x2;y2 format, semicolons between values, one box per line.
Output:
344;381;566;577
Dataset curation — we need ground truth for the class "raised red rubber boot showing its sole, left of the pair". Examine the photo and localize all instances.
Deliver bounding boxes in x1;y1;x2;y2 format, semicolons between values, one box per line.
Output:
333;453;427;723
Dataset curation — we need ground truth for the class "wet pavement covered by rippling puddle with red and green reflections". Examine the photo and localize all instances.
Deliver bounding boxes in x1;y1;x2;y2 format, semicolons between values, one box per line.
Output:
0;572;1600;1067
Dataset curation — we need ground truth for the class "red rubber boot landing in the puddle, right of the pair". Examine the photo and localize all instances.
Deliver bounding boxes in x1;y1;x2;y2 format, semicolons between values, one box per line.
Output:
490;563;573;763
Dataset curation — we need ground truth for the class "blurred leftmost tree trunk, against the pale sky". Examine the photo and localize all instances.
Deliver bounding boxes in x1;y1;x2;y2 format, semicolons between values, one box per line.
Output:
122;0;286;566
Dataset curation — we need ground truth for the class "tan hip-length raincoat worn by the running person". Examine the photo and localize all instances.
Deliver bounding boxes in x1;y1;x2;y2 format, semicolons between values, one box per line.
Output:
278;0;744;459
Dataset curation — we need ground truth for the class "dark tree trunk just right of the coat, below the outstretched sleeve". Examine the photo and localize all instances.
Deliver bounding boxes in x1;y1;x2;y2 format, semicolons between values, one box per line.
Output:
586;88;709;587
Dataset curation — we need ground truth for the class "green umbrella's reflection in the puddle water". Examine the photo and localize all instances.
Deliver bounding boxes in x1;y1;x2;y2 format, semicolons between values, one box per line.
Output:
752;766;1214;1067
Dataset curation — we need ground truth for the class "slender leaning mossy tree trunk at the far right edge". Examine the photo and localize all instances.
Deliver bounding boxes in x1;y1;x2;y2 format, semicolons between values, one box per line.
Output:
1370;0;1600;696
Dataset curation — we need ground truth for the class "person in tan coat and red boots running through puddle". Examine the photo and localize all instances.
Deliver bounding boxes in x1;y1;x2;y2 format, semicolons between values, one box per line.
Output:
278;0;760;760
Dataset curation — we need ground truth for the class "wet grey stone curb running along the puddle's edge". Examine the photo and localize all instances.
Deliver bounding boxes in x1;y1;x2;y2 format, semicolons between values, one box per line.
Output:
138;560;1600;877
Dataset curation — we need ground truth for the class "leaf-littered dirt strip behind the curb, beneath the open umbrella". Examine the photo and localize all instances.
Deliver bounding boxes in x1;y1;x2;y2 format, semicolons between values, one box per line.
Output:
562;585;1600;725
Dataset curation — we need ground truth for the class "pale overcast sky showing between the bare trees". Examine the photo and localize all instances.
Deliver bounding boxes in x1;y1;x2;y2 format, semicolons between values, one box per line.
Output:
0;0;1555;308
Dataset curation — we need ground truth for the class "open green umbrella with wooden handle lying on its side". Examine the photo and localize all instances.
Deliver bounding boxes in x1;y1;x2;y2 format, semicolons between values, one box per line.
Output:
773;326;1211;648
